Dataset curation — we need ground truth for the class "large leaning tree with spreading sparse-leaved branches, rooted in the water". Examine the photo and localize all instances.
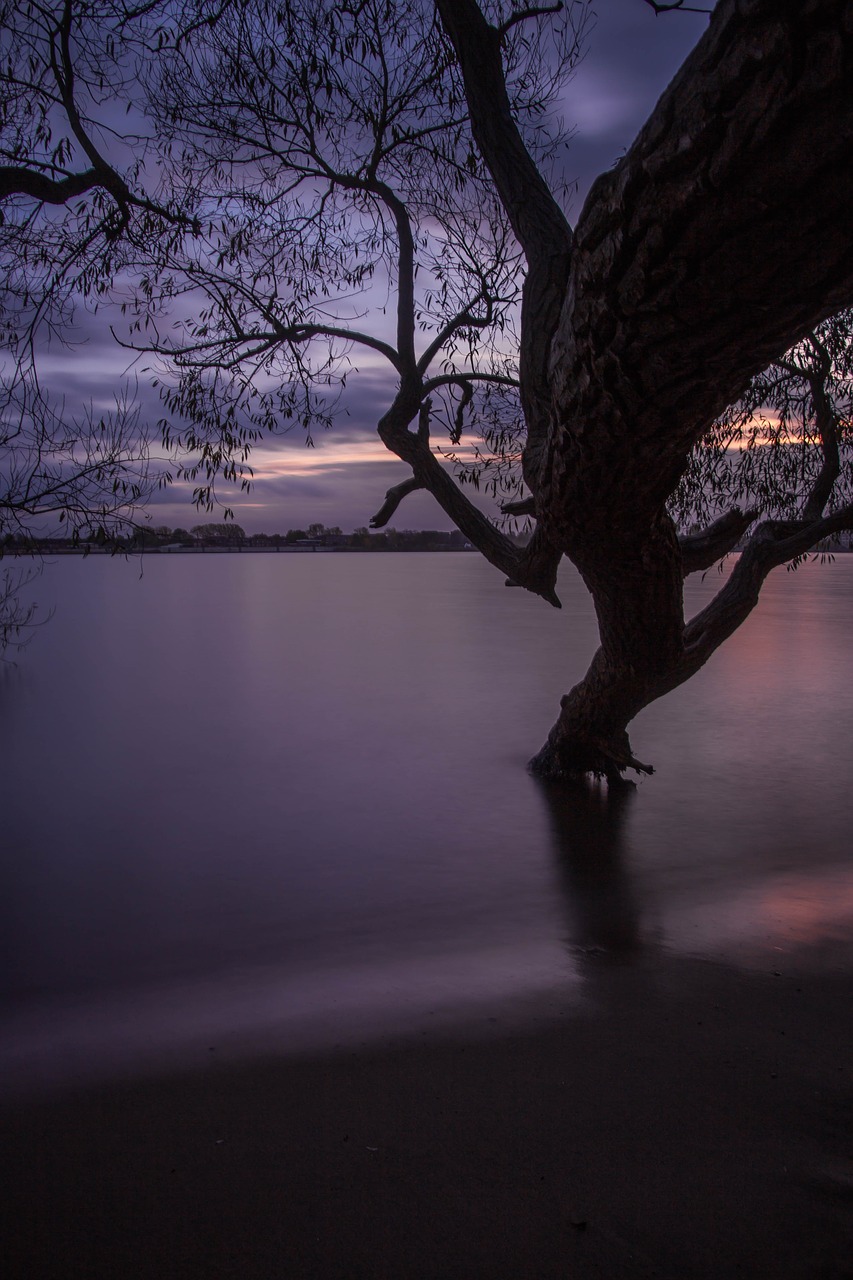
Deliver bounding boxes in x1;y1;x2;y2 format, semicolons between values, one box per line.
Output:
4;0;853;780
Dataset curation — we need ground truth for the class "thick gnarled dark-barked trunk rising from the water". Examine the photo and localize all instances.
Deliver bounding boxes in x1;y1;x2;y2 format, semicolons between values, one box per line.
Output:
437;0;853;778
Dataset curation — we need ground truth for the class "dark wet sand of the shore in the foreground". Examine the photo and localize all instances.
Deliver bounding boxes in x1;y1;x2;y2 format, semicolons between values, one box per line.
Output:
3;954;853;1280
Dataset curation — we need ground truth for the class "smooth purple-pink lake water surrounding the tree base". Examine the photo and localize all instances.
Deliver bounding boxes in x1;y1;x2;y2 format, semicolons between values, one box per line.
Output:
0;554;853;1084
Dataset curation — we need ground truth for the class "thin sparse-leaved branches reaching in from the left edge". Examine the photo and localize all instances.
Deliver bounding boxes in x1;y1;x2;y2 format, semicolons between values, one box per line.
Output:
0;0;186;652
